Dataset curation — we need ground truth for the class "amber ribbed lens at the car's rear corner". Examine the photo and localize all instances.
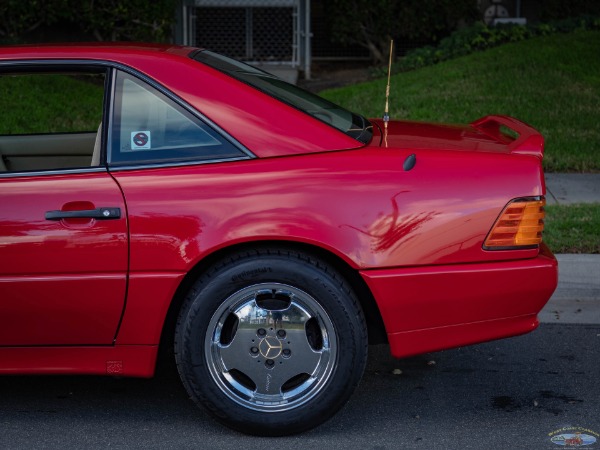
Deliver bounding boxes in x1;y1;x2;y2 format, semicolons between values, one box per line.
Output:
484;198;546;250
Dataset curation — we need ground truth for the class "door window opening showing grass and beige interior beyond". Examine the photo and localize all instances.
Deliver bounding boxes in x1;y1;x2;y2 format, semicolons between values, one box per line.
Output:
0;67;106;172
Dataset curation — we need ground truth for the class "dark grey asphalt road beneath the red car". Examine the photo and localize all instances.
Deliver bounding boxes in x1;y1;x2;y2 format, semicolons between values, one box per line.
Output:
0;323;600;450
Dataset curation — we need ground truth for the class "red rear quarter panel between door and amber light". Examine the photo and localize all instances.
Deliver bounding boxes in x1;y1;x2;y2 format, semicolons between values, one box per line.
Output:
113;143;544;345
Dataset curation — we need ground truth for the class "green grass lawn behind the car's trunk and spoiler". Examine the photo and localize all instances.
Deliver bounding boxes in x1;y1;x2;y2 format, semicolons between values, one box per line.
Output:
321;31;600;172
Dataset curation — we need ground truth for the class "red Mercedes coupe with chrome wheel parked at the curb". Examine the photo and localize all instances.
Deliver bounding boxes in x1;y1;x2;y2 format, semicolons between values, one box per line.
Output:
0;44;557;435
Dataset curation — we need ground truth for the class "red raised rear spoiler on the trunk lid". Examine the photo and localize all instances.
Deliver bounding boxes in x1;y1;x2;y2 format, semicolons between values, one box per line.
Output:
471;116;544;160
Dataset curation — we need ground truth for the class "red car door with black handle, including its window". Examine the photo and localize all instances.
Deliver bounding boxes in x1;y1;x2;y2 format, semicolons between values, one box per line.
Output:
0;63;128;346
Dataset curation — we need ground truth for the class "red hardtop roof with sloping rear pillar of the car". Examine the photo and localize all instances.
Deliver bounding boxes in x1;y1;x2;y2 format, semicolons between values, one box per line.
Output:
0;43;363;157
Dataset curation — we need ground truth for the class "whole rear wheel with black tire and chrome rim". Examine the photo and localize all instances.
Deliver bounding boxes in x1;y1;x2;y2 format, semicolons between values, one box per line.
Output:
175;249;367;436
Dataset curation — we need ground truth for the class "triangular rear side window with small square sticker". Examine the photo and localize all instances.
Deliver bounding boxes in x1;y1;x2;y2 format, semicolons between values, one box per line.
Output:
110;72;244;164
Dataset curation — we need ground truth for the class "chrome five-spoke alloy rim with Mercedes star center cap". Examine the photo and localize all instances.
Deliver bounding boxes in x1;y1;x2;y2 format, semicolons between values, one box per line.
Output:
205;283;337;412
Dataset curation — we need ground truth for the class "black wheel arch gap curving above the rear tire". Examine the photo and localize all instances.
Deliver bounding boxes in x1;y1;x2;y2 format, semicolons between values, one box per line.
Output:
159;240;387;364
